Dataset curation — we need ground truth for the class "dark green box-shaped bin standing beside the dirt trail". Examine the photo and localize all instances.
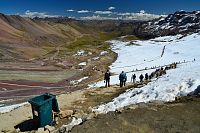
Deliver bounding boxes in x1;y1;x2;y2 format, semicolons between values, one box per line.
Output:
29;93;59;127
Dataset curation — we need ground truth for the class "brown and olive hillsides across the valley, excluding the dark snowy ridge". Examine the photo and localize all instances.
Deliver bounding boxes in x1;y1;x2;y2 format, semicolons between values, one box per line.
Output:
0;14;144;61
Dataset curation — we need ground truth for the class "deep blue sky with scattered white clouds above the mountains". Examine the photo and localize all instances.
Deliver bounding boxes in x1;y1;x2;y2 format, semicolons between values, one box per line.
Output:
0;0;200;17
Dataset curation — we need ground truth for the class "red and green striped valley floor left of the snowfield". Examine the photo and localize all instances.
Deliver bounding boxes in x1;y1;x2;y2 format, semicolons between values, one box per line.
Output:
0;47;116;105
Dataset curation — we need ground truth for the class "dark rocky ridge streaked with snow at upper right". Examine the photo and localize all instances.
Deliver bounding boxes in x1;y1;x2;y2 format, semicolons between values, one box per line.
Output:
142;11;200;37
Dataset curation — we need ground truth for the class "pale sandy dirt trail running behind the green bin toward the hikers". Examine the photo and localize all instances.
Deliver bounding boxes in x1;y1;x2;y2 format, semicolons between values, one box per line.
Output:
0;82;139;132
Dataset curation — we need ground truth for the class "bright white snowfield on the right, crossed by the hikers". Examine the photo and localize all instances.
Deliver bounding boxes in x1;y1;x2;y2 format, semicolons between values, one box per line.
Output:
93;33;200;113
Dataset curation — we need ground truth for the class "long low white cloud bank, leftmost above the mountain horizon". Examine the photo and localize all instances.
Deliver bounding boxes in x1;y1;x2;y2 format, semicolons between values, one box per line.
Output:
21;10;60;18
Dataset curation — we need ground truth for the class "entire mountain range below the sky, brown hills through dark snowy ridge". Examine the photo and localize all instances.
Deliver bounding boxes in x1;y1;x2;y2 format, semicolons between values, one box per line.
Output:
0;11;200;60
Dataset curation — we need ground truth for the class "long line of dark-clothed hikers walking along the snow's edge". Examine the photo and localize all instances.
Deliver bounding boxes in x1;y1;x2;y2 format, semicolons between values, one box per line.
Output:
104;63;177;87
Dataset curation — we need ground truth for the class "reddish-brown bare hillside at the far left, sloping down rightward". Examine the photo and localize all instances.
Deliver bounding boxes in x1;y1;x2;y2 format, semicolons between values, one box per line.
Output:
0;14;82;60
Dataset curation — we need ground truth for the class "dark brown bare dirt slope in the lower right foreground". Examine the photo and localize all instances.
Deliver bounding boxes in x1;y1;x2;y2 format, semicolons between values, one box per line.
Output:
72;97;200;133
